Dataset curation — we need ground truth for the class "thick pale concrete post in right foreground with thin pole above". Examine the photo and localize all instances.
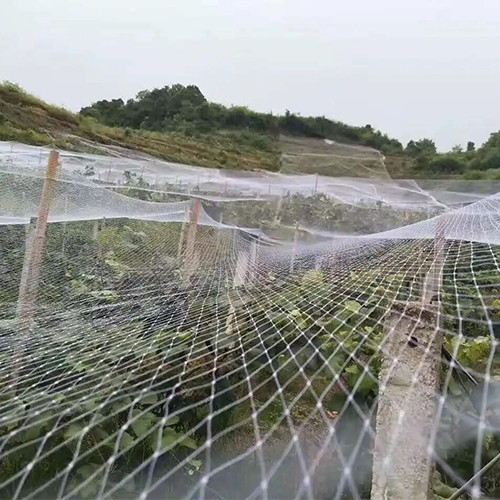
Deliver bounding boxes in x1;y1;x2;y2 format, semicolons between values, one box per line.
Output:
371;218;445;500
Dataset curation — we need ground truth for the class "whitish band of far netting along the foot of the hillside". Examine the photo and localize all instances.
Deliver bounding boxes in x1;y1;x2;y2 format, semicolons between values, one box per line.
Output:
0;143;500;211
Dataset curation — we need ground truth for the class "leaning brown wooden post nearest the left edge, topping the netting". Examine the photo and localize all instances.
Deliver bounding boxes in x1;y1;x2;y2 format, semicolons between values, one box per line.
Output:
17;151;59;333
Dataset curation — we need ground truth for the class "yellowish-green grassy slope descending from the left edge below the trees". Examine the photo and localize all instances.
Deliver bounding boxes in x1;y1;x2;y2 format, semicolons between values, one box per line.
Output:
0;83;279;170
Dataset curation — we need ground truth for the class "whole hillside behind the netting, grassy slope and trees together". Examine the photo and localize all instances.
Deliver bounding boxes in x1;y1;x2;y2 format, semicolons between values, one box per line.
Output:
0;82;500;179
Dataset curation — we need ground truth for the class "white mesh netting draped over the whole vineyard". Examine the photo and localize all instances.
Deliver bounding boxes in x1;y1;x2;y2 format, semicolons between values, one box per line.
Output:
0;146;500;499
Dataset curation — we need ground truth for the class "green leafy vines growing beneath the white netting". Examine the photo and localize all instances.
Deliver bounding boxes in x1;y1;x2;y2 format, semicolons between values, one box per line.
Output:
0;188;500;498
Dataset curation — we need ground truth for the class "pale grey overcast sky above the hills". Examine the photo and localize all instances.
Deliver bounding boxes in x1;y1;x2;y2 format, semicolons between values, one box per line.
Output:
0;0;500;149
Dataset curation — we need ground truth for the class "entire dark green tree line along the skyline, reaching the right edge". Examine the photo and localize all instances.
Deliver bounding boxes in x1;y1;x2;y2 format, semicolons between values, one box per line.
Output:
80;84;500;179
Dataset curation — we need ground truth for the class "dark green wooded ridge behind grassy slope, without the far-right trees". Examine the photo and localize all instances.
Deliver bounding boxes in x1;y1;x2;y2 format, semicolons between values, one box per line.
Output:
80;84;402;153
